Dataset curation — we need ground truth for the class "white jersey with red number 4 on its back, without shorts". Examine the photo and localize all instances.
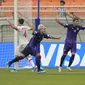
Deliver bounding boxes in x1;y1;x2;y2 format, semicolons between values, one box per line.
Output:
17;26;31;45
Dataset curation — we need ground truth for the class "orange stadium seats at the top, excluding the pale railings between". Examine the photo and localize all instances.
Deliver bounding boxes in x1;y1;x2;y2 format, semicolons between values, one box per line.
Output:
2;0;85;17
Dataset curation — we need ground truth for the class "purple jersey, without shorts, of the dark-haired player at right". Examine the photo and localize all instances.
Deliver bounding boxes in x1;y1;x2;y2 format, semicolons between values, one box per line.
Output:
65;24;85;42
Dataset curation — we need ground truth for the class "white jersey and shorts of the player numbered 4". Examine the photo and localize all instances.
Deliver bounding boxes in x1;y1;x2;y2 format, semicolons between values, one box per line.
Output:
15;26;31;55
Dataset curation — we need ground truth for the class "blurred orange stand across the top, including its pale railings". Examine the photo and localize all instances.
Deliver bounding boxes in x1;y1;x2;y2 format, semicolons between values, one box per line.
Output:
0;0;85;18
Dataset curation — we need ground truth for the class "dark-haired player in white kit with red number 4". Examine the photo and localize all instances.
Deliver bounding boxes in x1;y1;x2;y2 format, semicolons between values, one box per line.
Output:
7;18;36;72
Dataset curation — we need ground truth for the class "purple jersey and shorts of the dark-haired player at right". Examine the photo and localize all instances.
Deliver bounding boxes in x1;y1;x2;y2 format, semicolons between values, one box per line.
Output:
64;24;85;54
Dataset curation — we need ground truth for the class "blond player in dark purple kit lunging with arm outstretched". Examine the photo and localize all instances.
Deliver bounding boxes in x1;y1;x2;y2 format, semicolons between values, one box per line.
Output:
8;24;60;72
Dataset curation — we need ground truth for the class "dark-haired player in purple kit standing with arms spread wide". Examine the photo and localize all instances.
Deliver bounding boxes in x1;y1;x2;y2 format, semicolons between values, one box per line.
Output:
55;18;85;72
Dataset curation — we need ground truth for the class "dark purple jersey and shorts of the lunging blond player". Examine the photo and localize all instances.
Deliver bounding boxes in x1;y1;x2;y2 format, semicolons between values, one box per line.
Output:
22;32;50;56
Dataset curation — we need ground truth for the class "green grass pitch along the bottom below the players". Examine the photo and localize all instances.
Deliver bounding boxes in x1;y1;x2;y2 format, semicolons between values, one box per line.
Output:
0;68;85;85
